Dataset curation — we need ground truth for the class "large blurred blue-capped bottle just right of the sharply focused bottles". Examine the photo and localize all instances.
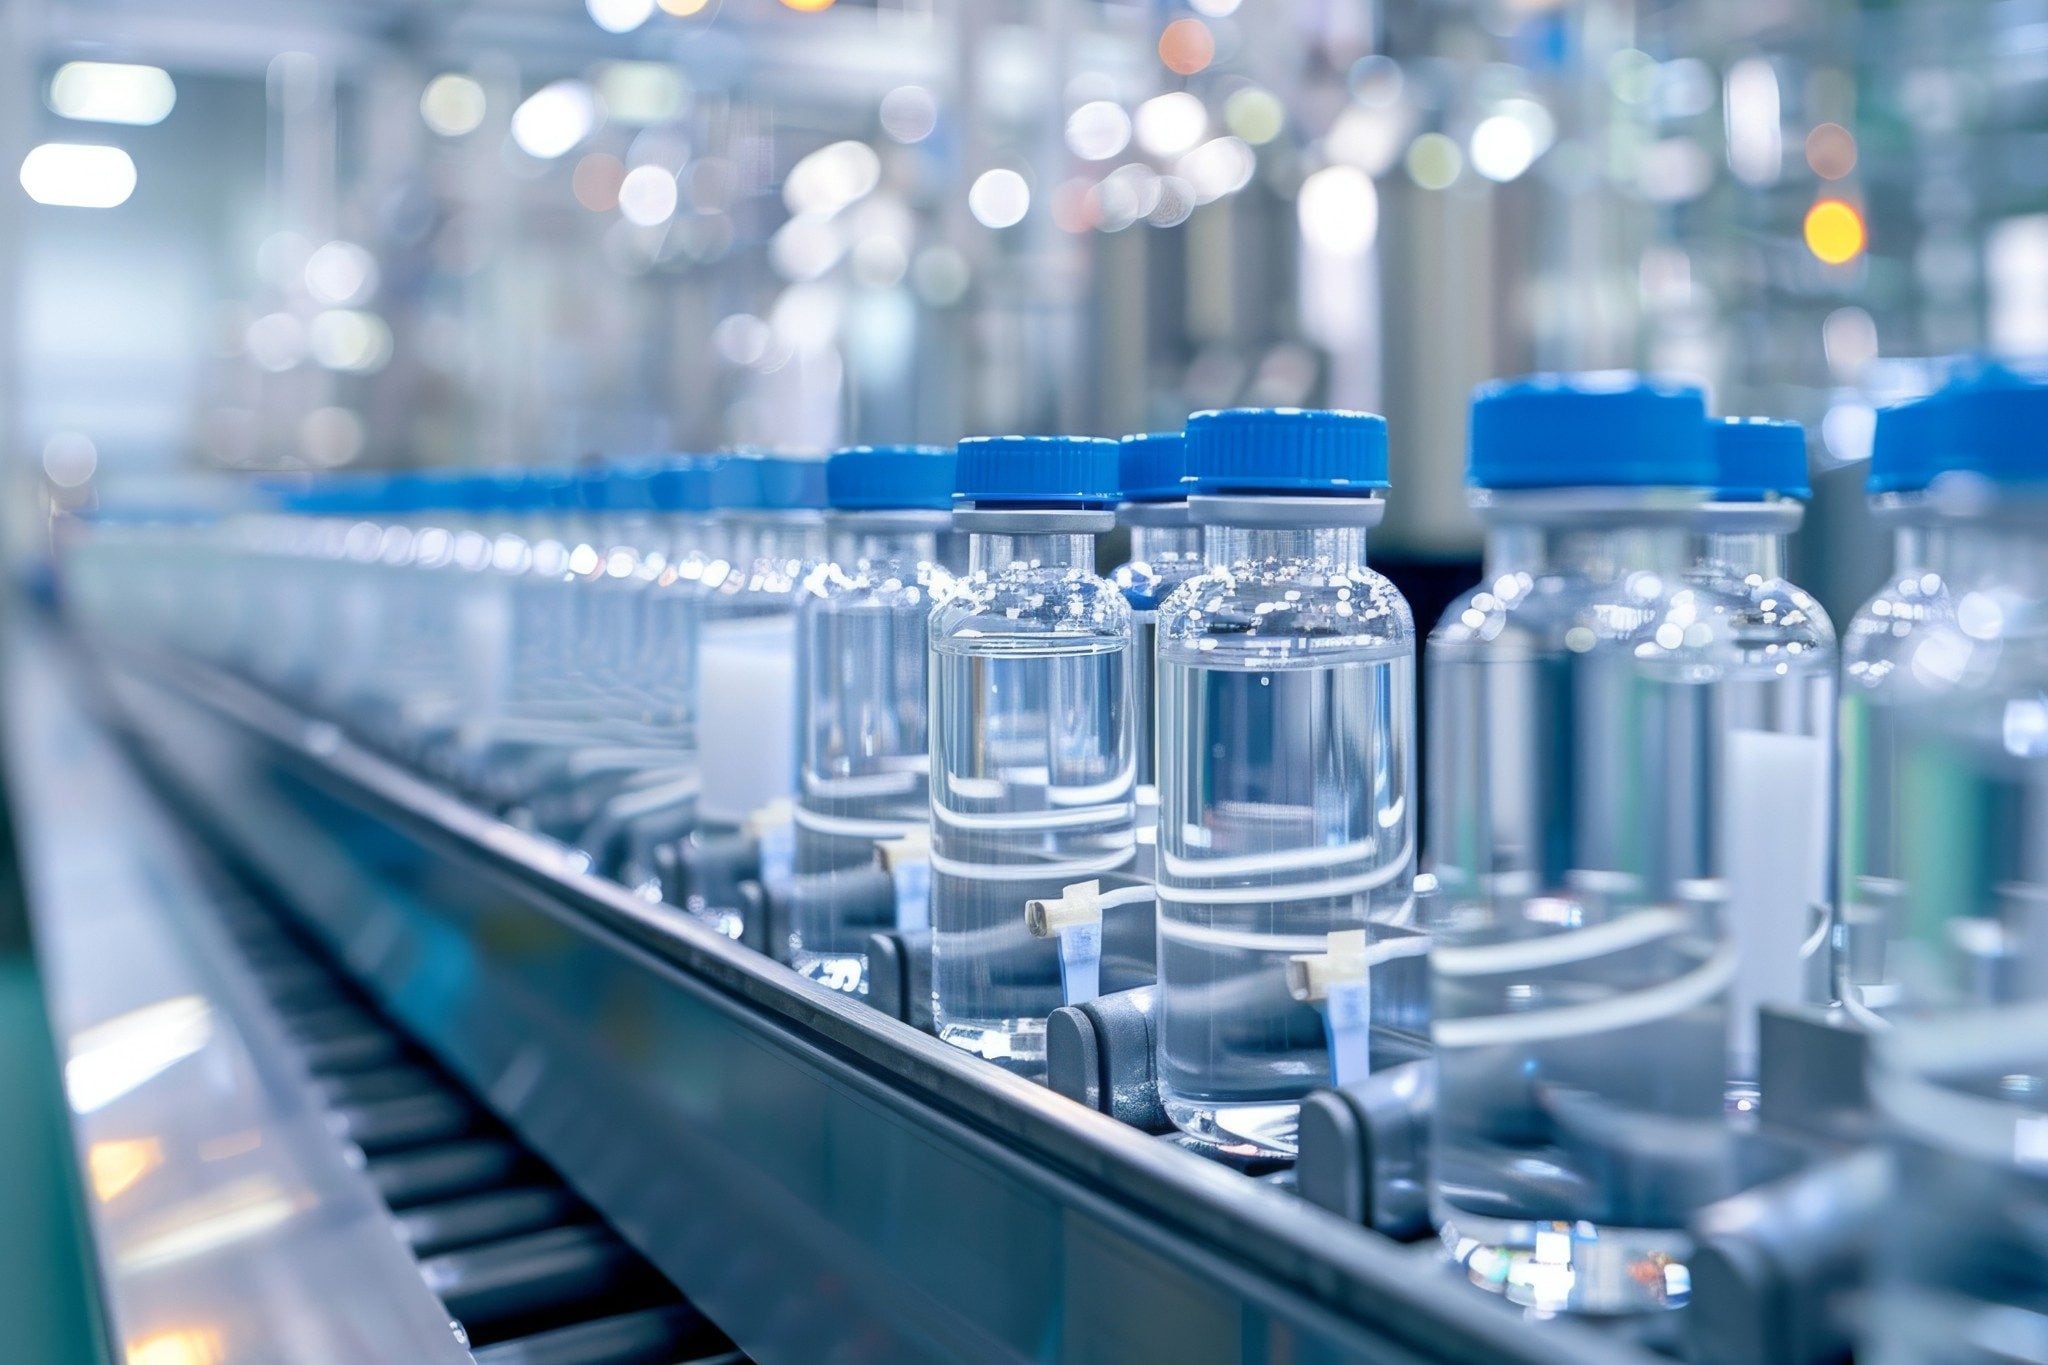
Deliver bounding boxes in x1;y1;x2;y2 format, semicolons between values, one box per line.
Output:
1425;375;1741;1312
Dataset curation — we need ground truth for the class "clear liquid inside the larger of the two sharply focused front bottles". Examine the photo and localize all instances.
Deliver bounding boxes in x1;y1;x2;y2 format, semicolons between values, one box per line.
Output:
1159;649;1427;1156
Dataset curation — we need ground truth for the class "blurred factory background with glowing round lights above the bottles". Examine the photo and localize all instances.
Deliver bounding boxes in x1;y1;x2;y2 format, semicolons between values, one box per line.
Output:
0;0;2048;612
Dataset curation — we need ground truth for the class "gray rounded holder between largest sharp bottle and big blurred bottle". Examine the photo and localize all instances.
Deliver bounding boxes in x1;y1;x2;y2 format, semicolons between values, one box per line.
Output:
1294;1060;1436;1240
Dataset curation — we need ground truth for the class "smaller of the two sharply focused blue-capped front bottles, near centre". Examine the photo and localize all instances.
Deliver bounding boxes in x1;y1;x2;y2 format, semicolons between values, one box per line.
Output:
930;436;1137;1076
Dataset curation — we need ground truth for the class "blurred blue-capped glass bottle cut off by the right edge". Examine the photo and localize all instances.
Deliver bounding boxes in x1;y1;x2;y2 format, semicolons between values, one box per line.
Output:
1858;366;2048;1365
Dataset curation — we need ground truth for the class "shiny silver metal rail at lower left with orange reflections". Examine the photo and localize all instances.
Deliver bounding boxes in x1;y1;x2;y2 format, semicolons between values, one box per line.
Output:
0;643;469;1365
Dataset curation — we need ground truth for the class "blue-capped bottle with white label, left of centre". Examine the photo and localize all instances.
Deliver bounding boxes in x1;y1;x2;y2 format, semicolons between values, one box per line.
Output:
684;456;825;937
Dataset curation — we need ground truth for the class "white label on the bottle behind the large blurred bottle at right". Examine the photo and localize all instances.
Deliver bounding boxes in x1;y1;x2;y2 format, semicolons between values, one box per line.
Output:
1720;731;1829;1072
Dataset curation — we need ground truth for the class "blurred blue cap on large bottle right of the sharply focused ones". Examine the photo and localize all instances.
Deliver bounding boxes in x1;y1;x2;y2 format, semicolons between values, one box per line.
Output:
1466;370;1714;489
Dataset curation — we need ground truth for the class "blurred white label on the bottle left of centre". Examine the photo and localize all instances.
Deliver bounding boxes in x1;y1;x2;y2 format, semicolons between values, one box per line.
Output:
696;616;797;825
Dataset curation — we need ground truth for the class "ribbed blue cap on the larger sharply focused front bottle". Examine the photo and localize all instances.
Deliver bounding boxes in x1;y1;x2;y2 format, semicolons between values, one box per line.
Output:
1188;407;1386;497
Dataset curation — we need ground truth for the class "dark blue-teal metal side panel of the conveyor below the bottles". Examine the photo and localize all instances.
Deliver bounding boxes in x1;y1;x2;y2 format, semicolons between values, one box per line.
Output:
99;642;1642;1363
